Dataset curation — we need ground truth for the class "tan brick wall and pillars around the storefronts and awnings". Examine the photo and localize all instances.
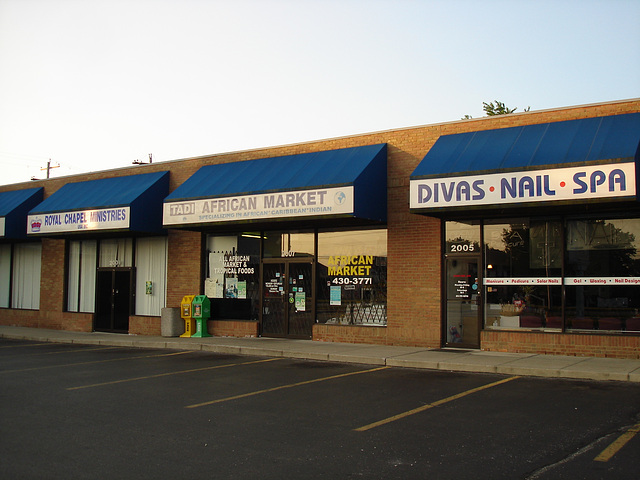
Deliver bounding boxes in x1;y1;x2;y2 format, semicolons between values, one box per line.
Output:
0;99;640;358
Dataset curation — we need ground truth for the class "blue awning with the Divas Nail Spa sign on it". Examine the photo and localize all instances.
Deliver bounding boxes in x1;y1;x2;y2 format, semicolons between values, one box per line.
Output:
410;113;640;213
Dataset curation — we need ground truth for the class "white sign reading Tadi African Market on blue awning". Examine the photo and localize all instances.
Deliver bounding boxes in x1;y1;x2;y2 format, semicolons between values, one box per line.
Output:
162;186;354;225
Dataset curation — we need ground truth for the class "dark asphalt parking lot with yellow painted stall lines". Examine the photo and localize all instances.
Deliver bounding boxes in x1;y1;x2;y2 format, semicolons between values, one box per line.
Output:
0;339;640;479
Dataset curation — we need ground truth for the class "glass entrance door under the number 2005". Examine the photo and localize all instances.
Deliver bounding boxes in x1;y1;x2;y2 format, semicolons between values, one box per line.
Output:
445;256;482;348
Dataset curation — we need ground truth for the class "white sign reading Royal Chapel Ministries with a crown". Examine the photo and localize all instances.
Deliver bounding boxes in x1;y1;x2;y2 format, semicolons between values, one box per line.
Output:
27;207;131;234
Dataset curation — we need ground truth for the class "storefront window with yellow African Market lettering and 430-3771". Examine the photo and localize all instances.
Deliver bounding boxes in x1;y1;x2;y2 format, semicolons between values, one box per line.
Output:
316;229;387;325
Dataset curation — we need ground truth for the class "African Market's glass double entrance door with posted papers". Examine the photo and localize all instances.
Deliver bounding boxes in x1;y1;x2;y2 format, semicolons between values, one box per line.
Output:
262;259;315;338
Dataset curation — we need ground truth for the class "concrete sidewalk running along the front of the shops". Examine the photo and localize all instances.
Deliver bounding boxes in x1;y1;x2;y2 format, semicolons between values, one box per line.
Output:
0;326;640;382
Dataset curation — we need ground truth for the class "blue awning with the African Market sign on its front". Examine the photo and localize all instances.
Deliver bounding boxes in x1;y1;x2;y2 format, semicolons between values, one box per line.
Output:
163;144;387;227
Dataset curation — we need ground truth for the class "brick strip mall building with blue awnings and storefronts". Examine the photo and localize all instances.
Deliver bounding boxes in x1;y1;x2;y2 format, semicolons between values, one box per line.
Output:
0;99;640;358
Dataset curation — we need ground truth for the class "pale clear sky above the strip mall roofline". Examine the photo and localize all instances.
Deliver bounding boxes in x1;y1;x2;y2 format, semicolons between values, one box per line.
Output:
0;0;640;184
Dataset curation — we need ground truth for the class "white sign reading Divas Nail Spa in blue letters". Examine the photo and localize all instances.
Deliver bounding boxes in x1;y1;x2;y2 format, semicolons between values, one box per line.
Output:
409;163;636;209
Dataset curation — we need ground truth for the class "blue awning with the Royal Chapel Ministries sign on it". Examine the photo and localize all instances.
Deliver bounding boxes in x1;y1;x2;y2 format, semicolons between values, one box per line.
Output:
27;172;169;235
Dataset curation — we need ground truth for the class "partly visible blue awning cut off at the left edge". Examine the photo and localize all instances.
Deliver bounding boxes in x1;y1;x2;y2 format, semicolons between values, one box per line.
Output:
0;187;44;239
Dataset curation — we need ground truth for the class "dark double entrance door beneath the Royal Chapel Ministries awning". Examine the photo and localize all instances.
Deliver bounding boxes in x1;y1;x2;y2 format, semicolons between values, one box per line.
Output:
94;268;133;333
